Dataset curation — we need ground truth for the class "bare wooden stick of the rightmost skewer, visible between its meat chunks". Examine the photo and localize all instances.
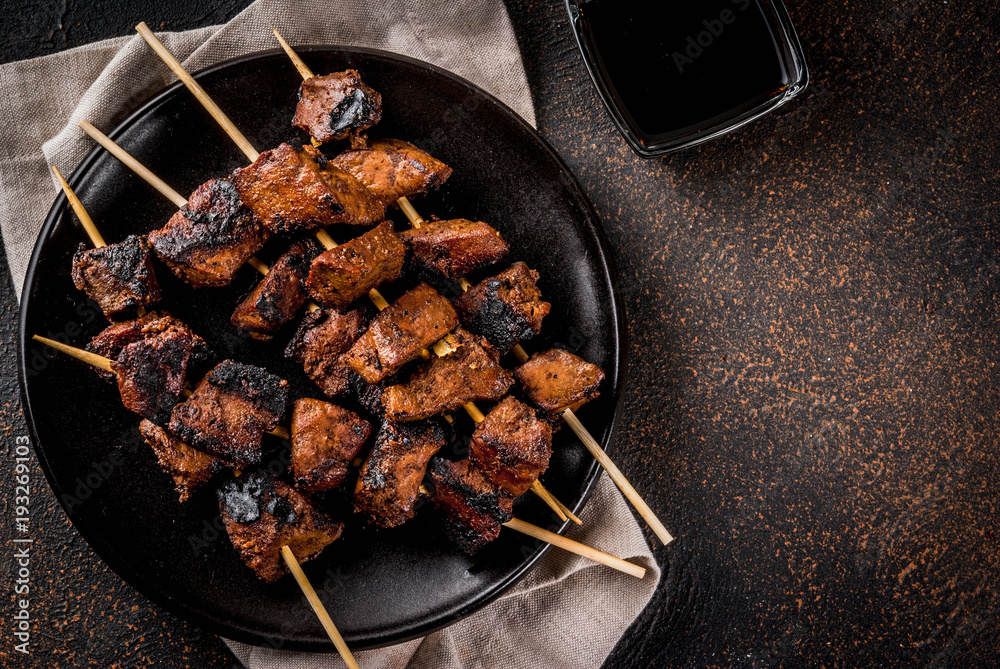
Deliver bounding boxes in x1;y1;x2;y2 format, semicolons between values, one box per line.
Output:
272;30;673;544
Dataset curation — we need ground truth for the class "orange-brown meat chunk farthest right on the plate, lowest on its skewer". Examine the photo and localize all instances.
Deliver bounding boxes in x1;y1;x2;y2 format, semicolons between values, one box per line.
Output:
514;348;604;416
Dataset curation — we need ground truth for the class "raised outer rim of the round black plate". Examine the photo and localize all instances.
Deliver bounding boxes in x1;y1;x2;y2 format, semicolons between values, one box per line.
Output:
16;44;628;653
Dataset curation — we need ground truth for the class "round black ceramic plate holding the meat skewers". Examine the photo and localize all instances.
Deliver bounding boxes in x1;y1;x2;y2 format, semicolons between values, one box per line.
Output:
20;47;623;650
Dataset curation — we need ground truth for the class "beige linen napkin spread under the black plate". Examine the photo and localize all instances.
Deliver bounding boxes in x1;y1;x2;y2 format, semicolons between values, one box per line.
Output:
0;0;660;669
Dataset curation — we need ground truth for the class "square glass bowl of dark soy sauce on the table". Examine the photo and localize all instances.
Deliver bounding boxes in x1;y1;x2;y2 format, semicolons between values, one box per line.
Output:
576;0;792;146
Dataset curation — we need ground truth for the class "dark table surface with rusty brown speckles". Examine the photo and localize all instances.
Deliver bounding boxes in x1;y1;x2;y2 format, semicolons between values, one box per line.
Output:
0;0;1000;669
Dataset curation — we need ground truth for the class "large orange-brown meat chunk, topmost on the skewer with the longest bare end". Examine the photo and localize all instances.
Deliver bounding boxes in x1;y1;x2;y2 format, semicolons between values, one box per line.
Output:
232;144;385;233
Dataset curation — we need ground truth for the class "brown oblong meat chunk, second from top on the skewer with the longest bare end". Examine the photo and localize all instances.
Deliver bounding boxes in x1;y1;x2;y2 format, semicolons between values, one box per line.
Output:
306;221;406;311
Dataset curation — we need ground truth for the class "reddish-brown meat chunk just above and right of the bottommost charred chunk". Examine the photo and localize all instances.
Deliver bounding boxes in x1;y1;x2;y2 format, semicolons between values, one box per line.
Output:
292;398;372;492
